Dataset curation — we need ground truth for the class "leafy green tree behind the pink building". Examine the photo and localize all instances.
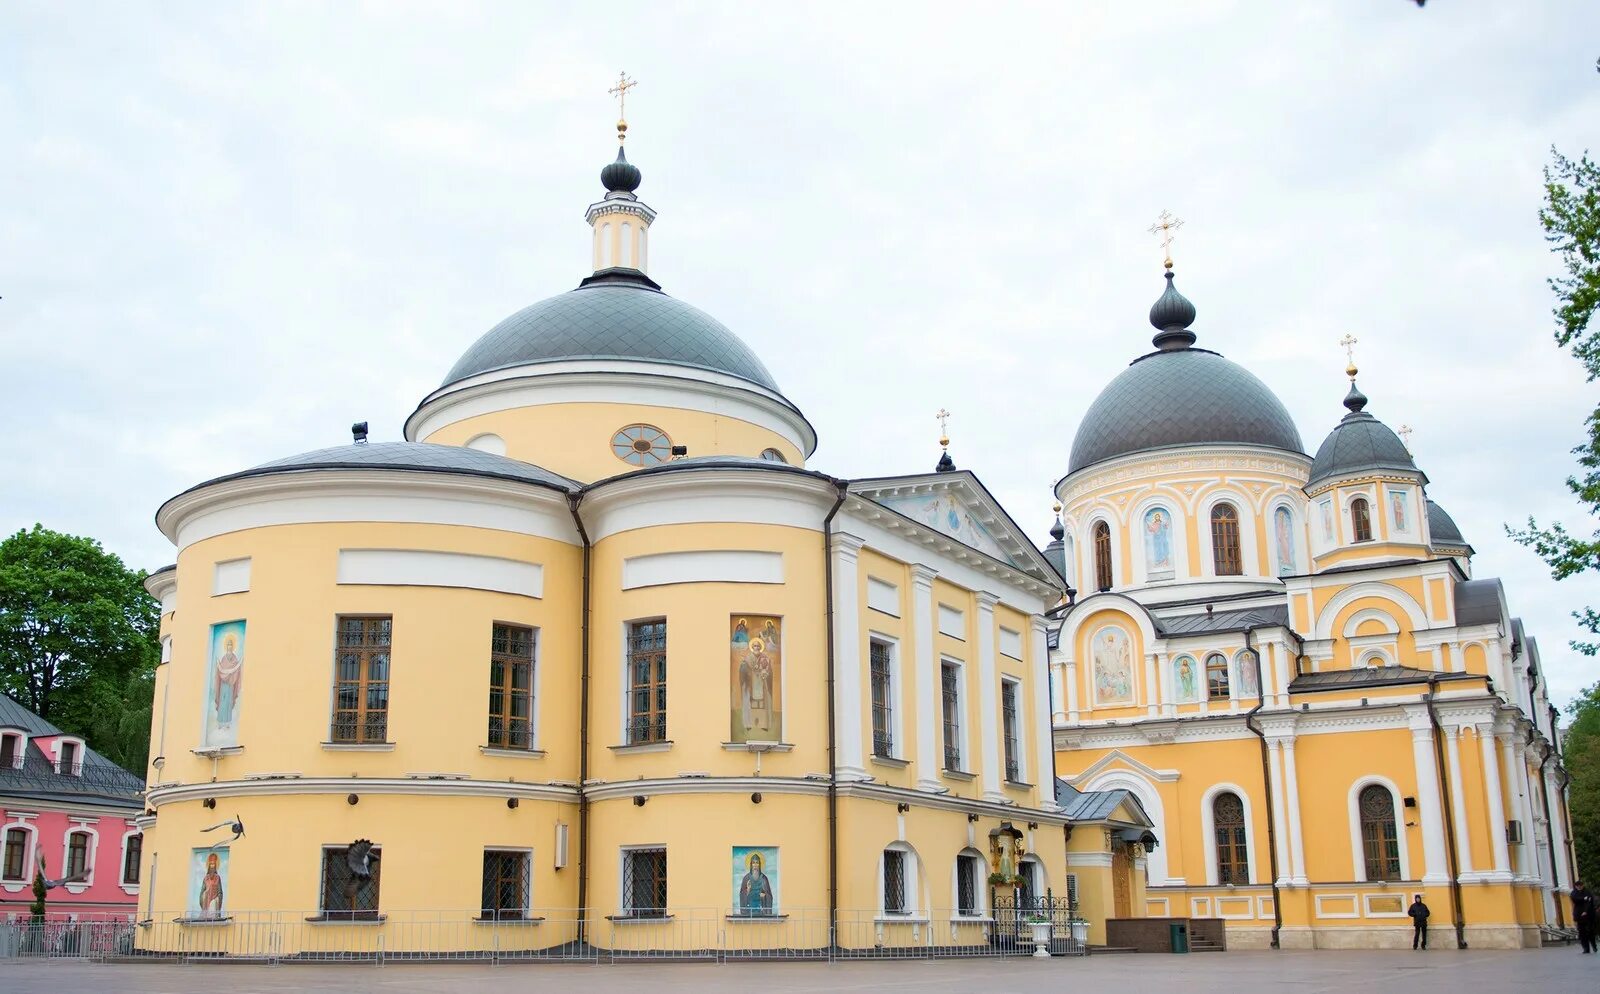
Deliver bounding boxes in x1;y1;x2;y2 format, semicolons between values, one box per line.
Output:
0;525;160;772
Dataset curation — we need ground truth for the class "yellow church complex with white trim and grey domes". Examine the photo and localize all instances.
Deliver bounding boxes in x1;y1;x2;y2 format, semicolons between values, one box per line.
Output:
128;114;1570;956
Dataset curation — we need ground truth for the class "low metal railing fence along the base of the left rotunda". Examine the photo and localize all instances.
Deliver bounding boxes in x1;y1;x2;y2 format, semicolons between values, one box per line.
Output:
0;901;1086;965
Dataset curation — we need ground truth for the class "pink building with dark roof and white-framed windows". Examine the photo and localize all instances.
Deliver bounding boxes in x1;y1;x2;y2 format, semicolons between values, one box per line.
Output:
0;695;144;922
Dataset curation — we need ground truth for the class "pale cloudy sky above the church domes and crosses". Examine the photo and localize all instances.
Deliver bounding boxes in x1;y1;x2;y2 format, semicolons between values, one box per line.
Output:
0;0;1600;699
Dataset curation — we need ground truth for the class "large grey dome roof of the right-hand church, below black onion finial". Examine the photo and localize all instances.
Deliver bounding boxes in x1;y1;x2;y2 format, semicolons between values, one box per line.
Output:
1067;349;1304;474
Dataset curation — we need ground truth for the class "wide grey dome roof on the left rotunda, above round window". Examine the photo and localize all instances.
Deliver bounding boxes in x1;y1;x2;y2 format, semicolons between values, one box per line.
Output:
445;271;778;392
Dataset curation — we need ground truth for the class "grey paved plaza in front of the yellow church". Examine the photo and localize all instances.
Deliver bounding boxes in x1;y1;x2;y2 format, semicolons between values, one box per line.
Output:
0;948;1600;994
